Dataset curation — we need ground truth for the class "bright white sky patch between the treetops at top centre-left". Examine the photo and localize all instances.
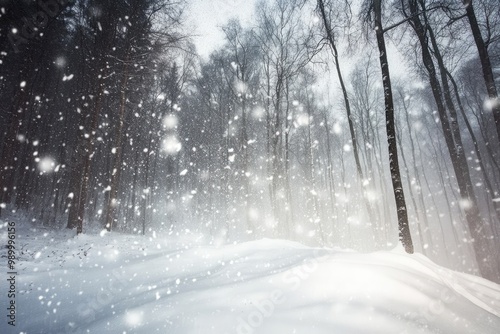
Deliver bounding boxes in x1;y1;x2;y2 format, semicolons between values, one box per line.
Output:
186;0;256;58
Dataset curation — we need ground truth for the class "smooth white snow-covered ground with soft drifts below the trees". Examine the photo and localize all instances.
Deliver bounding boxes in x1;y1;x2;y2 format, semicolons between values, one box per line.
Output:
0;218;500;334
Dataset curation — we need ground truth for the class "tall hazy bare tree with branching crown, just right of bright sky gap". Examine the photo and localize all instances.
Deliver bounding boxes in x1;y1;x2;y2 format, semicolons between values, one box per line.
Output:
255;0;318;235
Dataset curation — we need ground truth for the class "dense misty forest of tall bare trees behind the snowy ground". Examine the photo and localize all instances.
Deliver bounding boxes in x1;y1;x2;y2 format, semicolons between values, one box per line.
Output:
0;0;500;282
